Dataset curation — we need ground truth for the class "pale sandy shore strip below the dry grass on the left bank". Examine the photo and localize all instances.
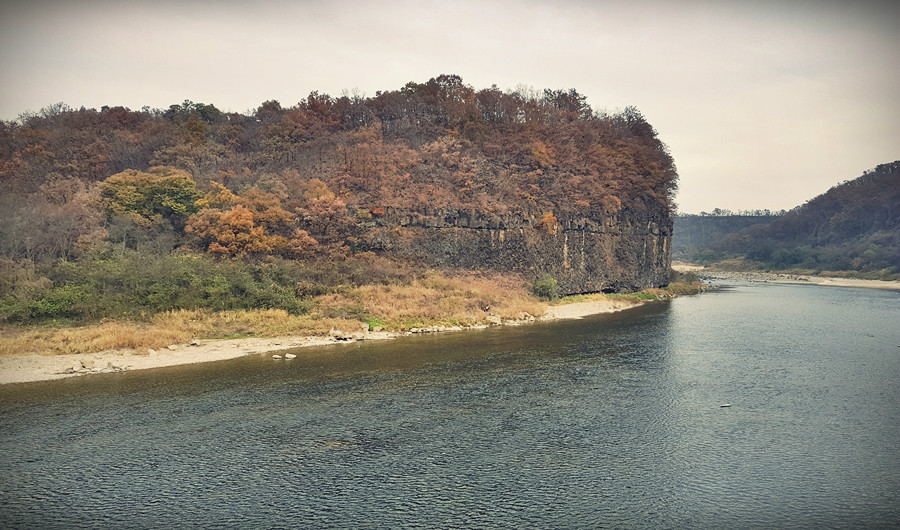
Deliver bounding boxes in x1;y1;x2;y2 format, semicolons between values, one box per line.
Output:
0;300;640;384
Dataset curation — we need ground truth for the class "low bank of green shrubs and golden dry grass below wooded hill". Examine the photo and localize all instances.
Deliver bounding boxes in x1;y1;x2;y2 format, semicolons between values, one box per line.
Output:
0;255;705;355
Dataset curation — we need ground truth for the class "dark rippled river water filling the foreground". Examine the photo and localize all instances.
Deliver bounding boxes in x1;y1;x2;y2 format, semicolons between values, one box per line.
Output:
0;284;900;528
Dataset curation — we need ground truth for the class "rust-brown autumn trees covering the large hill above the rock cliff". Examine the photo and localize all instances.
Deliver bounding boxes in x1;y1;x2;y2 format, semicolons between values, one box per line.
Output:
0;75;677;264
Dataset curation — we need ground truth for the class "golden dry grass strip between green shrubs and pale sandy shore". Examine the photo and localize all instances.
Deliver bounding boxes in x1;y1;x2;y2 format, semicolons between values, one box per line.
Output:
0;272;544;355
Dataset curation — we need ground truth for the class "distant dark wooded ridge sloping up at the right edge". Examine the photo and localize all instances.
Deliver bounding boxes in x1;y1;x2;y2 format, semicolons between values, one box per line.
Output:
675;161;900;273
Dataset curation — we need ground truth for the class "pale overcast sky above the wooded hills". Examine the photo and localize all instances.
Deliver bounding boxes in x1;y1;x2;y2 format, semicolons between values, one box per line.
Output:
0;0;900;213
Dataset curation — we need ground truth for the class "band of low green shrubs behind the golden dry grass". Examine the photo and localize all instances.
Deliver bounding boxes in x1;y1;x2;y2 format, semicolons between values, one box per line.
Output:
0;246;426;325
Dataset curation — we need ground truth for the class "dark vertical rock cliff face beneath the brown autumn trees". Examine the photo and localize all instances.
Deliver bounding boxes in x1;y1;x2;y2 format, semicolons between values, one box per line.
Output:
365;208;672;294
